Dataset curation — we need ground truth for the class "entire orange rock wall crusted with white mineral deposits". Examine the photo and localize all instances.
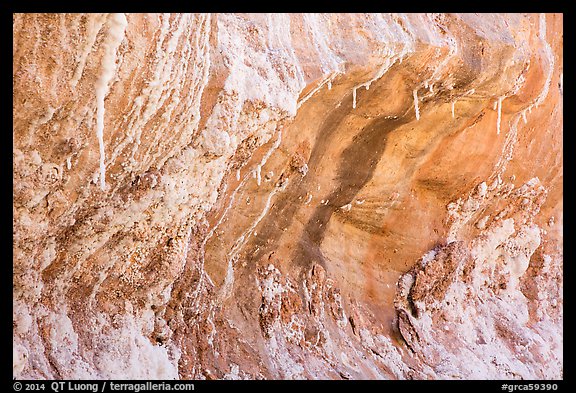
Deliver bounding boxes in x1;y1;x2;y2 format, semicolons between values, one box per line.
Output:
13;14;563;379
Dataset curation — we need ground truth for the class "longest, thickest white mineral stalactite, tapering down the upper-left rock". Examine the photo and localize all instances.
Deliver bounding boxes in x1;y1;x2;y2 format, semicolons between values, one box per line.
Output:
95;14;128;190
